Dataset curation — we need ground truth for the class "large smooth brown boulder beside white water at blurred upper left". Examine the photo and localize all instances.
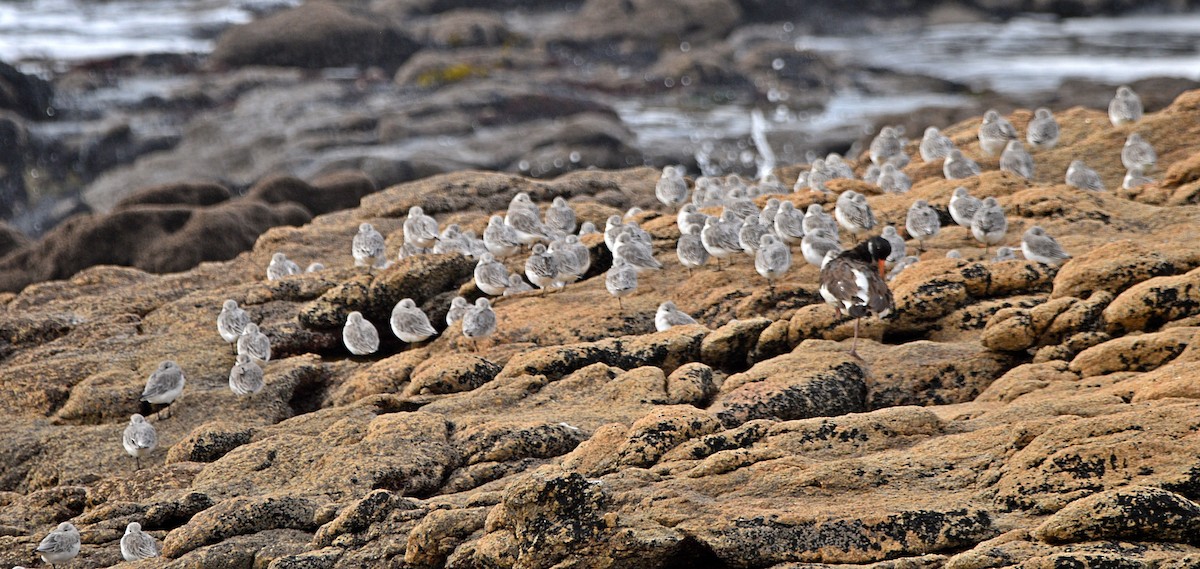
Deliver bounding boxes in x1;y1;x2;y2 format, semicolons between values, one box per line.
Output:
211;2;416;68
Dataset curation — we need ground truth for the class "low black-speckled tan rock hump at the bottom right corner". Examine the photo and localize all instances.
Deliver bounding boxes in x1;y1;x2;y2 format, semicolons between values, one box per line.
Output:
1033;486;1200;545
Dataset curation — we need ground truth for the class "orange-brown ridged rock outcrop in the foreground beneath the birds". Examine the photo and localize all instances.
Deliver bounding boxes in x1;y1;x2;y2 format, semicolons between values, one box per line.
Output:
0;86;1200;569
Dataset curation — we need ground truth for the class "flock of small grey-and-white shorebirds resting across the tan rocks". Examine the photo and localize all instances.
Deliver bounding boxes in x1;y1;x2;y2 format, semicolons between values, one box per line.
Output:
28;86;1157;565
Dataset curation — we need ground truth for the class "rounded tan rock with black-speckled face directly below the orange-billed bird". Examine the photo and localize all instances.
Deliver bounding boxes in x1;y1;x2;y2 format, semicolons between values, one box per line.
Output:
713;341;866;427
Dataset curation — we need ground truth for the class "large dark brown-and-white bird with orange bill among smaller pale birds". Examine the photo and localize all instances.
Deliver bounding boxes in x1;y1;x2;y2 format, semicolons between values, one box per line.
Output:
820;236;895;358
